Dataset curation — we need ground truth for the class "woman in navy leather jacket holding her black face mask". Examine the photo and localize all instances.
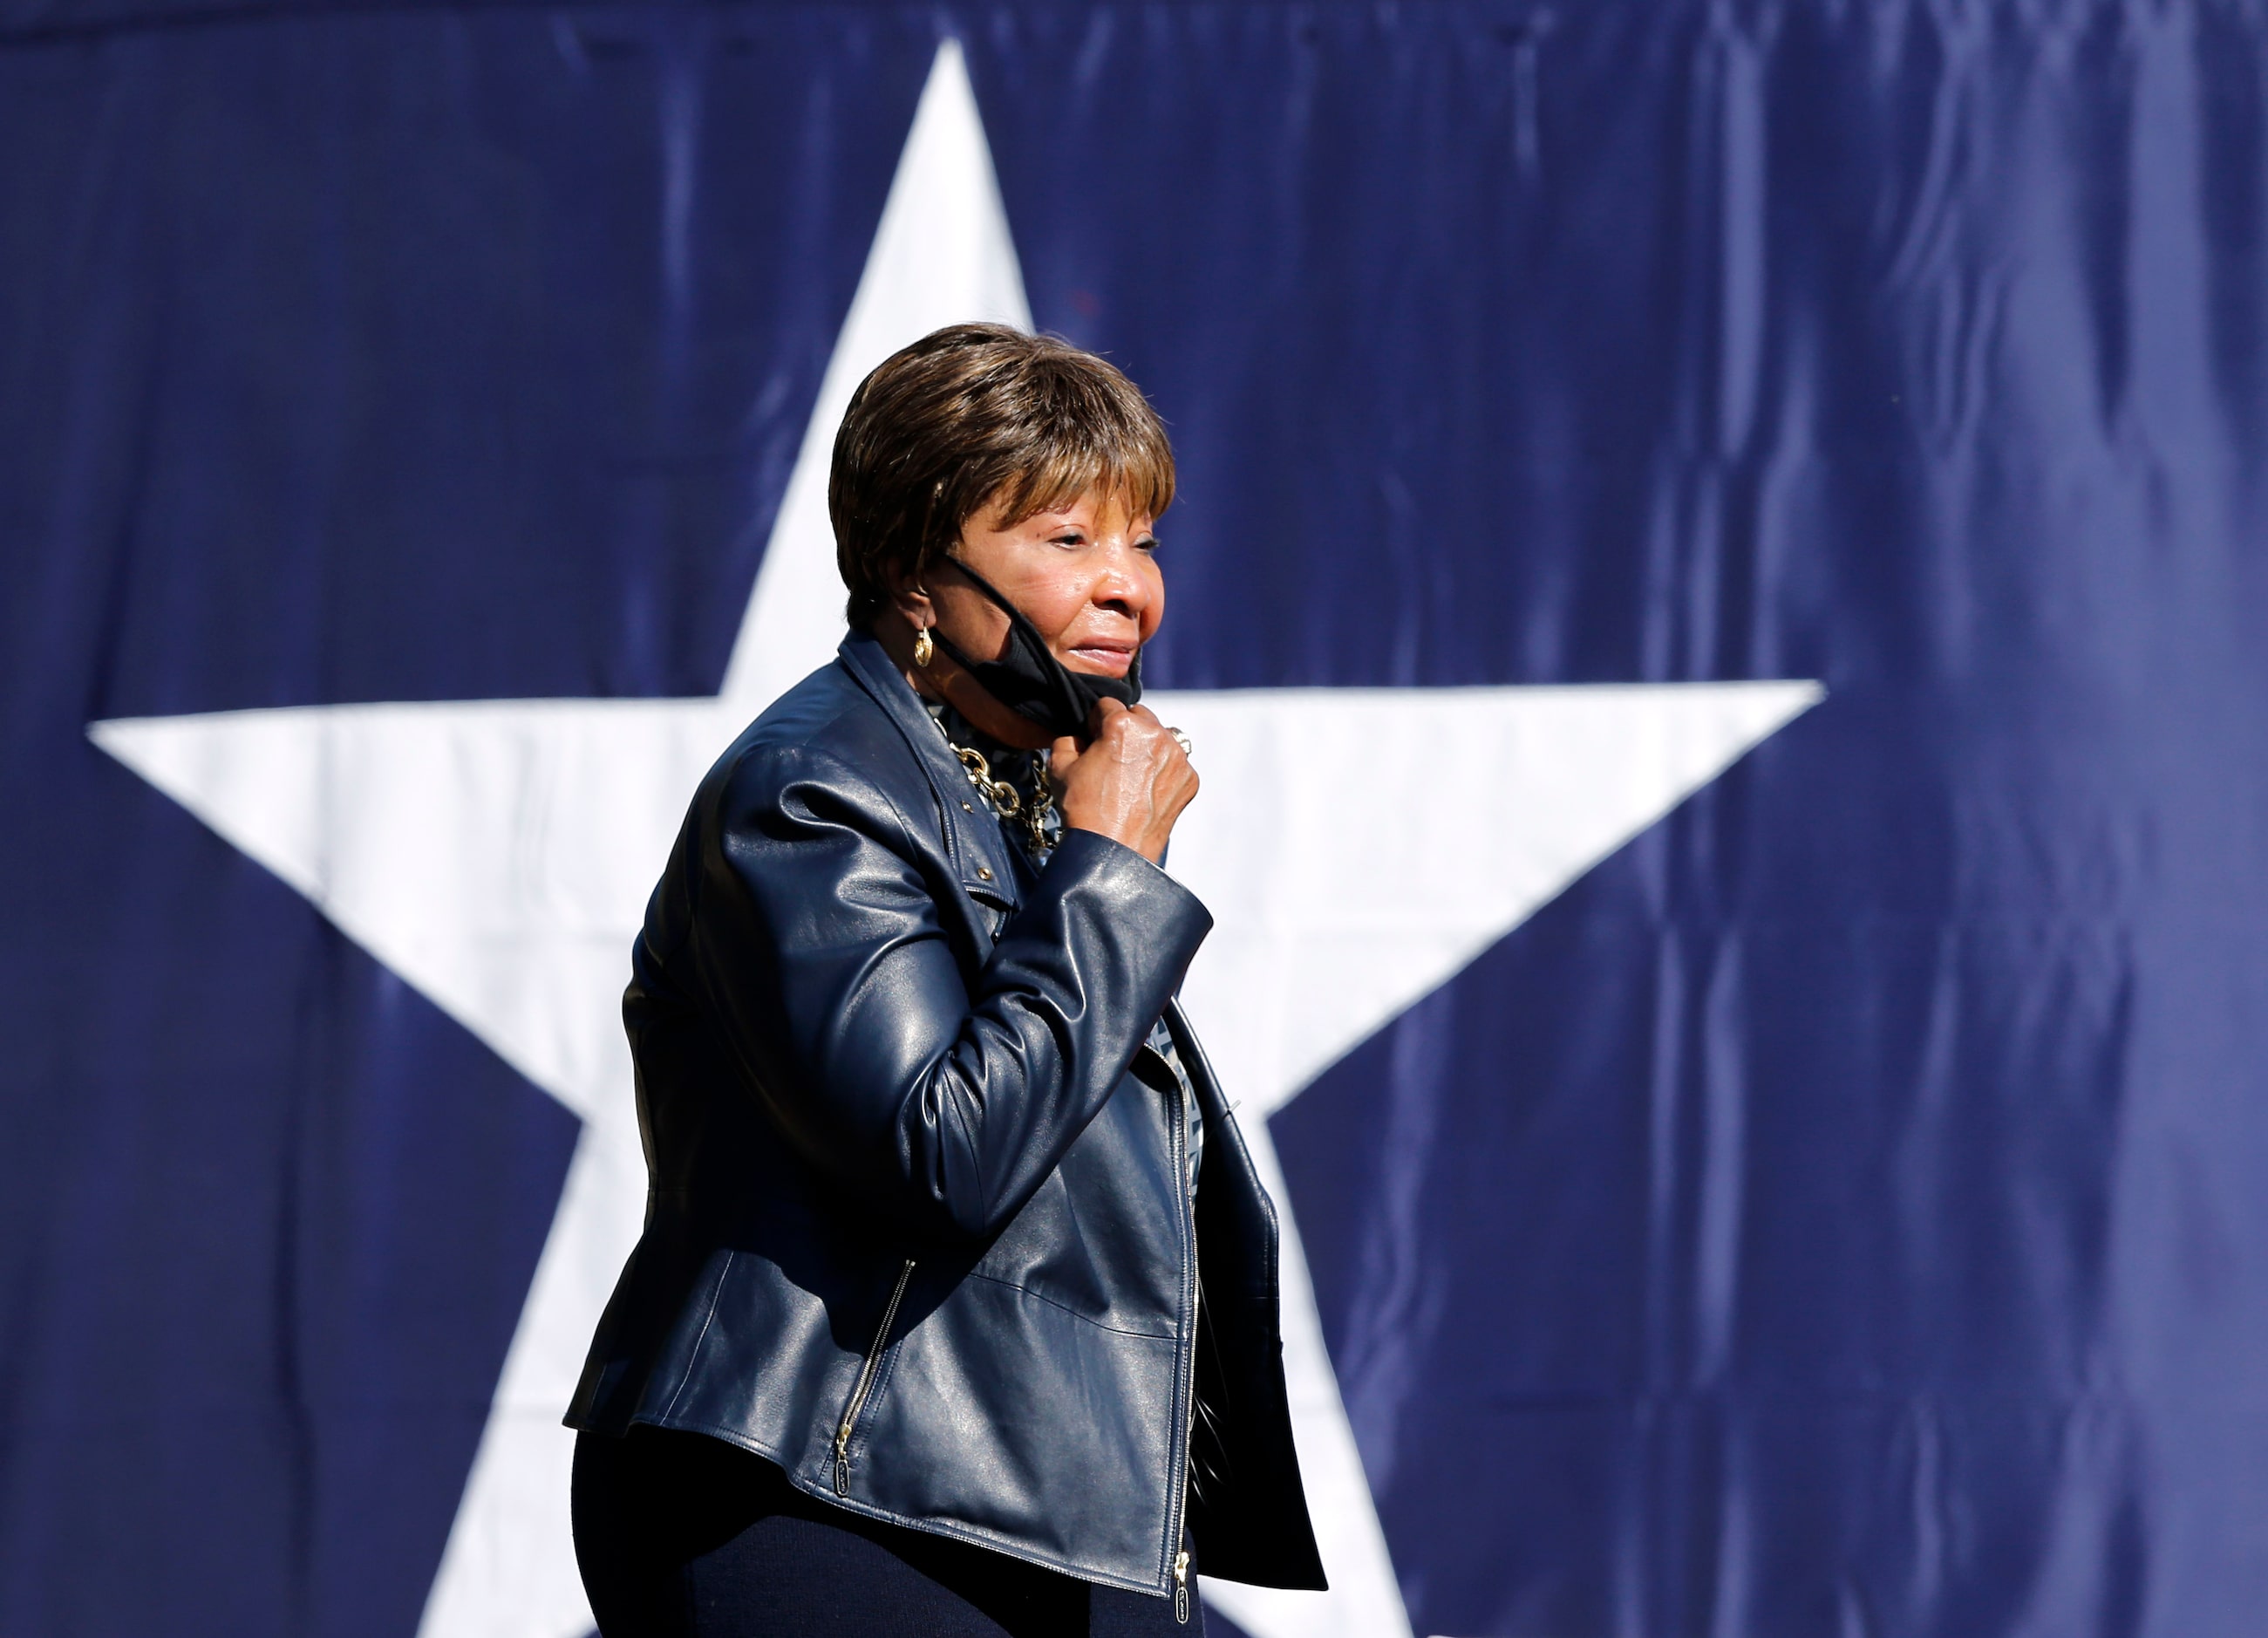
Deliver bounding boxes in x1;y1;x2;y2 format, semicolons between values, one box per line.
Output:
567;324;1322;1638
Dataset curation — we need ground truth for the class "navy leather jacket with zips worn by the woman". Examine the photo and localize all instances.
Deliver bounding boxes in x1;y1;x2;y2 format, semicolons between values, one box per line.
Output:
567;633;1322;1593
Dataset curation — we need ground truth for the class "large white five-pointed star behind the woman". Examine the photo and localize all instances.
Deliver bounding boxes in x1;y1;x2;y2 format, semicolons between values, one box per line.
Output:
88;43;1819;1638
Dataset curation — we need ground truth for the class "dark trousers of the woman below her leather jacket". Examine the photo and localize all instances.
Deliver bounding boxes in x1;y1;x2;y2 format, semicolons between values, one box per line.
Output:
574;1427;1204;1638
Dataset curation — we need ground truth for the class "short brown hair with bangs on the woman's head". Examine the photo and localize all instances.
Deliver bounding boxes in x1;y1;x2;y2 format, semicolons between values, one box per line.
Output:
828;324;1173;626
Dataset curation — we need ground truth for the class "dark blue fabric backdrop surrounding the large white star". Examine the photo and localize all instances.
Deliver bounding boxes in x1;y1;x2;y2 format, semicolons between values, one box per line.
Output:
0;0;2268;1638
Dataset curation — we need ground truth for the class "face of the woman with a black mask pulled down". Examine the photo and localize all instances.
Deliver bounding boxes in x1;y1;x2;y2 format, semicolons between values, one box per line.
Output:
928;490;1166;676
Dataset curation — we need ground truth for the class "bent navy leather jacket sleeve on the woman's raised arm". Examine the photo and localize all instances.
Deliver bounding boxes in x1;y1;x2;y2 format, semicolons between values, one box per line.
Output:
690;748;1211;1237
